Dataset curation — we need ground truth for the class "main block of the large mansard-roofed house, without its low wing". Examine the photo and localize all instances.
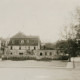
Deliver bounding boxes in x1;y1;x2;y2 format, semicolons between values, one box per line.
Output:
8;32;40;55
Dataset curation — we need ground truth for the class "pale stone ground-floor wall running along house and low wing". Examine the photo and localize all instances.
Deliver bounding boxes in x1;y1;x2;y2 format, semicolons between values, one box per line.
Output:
3;46;60;59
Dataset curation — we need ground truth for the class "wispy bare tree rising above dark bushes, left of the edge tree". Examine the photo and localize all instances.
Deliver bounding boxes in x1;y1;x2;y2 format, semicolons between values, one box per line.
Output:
61;24;76;61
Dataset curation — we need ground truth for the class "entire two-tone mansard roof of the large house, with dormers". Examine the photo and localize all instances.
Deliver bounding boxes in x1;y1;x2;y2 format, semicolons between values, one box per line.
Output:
8;32;40;46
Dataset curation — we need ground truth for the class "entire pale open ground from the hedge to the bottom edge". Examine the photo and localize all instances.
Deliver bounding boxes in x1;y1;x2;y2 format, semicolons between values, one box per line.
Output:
0;58;80;80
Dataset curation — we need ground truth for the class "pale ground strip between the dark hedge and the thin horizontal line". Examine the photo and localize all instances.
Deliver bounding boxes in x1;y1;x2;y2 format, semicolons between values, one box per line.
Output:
0;60;68;68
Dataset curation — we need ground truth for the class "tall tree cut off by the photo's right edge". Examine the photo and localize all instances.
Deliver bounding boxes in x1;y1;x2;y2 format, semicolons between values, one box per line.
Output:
73;7;80;56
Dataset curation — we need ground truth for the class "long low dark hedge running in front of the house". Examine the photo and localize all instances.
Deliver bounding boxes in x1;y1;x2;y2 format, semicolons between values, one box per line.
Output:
2;56;69;61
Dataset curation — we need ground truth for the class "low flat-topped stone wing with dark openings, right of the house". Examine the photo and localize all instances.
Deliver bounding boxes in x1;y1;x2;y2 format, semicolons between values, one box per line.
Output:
34;50;59;59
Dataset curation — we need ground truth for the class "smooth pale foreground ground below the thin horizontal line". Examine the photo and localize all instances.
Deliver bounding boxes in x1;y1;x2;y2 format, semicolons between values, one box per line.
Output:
0;68;75;80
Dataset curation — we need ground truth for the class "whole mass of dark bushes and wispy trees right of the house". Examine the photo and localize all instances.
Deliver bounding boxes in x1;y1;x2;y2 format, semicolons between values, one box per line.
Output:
56;7;80;61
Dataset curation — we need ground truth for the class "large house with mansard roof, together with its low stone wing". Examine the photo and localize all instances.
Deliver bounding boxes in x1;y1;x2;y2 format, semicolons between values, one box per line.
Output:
2;32;64;59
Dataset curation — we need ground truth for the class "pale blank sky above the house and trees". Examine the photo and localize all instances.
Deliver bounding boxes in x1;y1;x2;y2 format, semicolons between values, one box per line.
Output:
0;0;80;42
